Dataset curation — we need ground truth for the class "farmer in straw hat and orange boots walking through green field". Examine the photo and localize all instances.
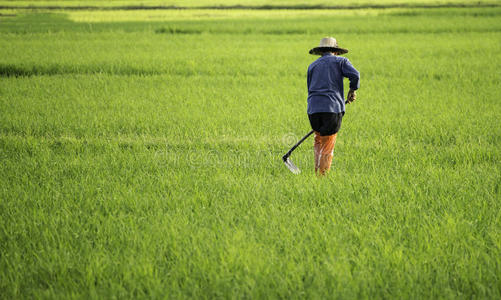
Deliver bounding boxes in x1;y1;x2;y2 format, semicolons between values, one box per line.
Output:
308;37;360;176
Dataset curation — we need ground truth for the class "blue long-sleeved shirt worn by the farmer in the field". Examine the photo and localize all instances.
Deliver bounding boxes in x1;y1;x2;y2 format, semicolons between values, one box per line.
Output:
308;53;360;115
